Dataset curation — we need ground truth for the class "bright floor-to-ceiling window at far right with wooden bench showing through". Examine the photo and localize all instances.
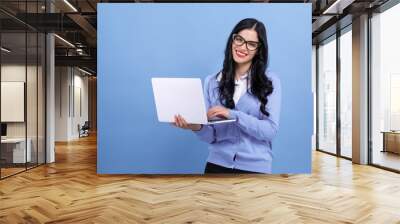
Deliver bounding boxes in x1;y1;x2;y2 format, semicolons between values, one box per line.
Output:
370;1;400;170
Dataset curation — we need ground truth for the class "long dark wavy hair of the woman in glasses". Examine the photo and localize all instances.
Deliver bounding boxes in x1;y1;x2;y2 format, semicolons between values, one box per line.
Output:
218;18;273;116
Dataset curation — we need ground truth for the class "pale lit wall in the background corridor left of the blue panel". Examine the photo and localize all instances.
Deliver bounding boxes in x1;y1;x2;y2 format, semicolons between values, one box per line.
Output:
55;67;88;141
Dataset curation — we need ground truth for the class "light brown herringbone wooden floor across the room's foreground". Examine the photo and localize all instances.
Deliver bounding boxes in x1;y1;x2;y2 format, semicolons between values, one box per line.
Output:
0;134;400;224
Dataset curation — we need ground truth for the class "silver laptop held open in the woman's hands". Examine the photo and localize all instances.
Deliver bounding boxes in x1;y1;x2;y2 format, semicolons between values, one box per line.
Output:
151;78;236;124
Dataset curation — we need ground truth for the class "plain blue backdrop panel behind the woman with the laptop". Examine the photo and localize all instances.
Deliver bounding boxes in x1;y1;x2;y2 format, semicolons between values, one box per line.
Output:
97;3;313;174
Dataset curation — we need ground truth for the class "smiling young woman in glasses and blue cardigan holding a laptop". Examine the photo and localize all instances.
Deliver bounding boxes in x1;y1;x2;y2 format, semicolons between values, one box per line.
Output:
173;18;281;173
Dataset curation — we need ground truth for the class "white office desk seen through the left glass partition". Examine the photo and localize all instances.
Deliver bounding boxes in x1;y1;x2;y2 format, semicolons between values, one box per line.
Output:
1;138;32;163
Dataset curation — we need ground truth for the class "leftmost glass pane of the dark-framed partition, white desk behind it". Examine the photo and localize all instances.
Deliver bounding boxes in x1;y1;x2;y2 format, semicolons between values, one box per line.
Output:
0;32;27;177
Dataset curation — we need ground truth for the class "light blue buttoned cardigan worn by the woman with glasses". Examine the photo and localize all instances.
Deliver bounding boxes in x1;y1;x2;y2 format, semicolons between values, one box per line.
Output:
194;71;281;173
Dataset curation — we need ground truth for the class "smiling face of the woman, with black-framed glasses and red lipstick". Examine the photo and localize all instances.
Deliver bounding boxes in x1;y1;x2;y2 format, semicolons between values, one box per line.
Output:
232;29;259;64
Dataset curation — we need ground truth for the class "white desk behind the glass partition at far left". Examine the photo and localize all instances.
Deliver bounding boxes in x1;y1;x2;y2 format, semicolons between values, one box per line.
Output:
1;138;32;163
